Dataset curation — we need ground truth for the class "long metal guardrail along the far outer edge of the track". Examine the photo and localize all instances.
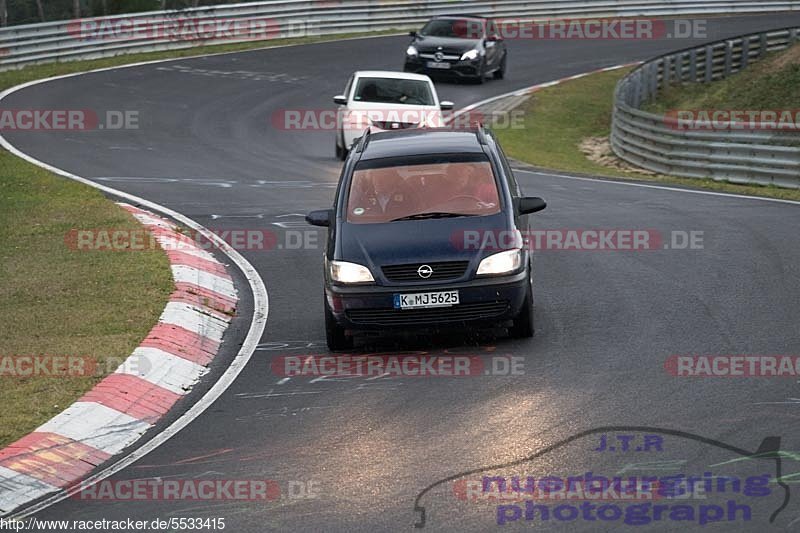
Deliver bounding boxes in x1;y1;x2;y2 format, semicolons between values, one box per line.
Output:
0;0;800;70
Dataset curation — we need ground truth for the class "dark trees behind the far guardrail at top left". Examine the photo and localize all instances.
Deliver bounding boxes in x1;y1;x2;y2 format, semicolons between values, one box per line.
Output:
0;0;250;26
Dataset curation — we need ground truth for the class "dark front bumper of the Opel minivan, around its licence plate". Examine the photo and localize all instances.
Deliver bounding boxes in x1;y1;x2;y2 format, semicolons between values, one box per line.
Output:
325;270;528;331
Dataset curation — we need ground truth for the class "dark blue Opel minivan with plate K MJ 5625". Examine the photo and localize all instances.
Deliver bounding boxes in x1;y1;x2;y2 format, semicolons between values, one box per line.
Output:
306;127;546;350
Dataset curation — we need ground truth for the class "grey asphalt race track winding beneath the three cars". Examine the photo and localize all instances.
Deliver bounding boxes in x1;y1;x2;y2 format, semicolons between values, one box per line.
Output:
4;10;800;533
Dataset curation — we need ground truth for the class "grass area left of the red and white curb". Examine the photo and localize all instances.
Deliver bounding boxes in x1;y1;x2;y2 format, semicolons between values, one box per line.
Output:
0;151;172;448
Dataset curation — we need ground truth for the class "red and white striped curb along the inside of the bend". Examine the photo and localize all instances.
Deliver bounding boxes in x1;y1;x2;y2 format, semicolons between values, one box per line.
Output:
0;203;238;515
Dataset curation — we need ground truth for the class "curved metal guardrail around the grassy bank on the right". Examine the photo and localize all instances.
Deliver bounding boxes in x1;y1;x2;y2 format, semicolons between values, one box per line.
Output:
611;28;800;188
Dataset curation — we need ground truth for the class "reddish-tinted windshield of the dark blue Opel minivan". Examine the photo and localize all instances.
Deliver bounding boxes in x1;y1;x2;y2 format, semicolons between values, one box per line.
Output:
347;154;500;224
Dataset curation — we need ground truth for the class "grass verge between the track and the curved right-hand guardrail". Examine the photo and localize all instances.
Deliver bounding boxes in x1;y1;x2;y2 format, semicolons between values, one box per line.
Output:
495;69;800;200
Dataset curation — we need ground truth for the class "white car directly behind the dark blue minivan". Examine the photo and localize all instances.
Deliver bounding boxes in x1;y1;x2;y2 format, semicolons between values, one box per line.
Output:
333;70;453;160
